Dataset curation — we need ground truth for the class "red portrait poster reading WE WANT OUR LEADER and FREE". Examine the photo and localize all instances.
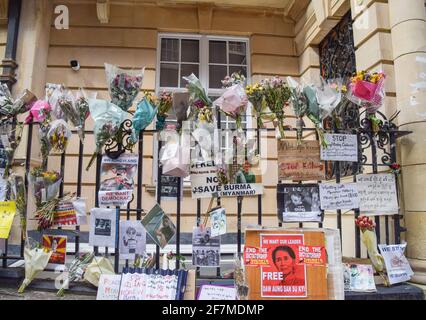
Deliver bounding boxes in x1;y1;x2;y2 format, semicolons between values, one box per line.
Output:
260;234;307;298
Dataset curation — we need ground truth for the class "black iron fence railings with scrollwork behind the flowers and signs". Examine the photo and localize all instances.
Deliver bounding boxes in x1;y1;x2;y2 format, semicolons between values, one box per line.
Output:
0;108;409;276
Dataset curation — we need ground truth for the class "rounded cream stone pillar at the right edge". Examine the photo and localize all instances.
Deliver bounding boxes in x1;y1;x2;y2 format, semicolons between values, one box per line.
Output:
388;0;426;284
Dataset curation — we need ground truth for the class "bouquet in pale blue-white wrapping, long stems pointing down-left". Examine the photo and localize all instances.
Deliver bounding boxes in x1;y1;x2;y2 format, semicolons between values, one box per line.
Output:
86;99;126;171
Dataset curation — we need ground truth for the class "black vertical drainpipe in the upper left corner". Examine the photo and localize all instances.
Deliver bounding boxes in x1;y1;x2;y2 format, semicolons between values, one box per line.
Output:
0;0;22;89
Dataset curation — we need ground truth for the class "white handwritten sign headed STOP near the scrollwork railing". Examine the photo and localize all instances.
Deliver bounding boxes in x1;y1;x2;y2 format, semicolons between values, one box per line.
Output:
321;133;358;162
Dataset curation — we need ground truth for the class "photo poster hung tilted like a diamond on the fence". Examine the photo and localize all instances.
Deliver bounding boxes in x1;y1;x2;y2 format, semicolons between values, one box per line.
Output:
142;204;176;249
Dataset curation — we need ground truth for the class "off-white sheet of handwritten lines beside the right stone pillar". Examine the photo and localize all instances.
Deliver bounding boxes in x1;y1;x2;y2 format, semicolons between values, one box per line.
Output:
357;173;398;215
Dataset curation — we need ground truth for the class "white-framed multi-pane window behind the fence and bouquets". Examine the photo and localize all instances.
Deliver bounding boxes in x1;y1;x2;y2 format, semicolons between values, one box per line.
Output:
153;33;252;183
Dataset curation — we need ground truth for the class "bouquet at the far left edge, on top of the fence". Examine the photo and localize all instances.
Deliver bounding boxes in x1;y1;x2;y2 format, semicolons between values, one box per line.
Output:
0;83;37;119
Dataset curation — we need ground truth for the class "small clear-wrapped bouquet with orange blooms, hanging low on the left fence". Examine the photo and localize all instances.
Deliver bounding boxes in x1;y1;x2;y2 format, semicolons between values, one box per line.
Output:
28;167;62;208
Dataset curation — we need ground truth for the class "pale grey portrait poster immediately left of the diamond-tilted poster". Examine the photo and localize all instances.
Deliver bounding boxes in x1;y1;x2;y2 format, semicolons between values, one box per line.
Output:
119;220;146;260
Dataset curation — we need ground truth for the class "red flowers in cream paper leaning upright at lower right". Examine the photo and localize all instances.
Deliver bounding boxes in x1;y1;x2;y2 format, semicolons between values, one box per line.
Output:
355;216;388;283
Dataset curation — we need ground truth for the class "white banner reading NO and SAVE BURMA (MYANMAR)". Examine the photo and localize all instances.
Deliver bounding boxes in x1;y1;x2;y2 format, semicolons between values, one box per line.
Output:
190;161;263;199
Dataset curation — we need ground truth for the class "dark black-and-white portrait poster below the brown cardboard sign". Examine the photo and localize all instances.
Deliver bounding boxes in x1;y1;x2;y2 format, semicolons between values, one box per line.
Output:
277;184;323;222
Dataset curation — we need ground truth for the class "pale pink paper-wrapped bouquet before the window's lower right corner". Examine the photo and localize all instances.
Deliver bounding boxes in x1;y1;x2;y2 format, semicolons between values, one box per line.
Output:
213;73;248;130
